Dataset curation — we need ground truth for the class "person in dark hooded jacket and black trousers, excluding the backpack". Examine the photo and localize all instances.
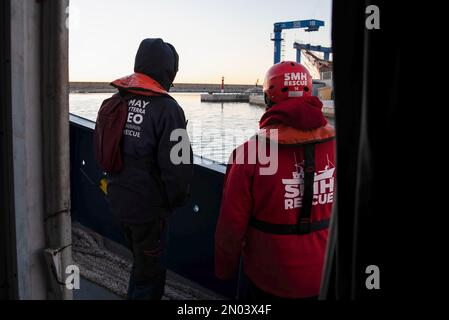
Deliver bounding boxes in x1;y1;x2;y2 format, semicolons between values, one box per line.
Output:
107;39;193;299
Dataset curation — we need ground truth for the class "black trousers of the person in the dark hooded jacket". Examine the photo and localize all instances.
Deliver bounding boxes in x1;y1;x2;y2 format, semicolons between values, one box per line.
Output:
122;219;166;300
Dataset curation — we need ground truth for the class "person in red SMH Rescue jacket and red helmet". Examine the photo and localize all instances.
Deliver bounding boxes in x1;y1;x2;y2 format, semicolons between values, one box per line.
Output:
215;61;336;300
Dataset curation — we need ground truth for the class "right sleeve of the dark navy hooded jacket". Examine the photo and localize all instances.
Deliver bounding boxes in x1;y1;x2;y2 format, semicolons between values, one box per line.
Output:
157;99;193;208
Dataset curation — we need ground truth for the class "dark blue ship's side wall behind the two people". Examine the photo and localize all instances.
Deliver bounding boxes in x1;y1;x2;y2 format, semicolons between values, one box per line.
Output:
70;116;237;297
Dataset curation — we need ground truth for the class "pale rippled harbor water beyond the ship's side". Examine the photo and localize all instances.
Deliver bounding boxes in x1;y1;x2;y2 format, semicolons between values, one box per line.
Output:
70;93;332;163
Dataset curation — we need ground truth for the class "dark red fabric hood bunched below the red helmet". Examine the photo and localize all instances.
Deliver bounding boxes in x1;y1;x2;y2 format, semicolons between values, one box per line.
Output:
259;96;327;130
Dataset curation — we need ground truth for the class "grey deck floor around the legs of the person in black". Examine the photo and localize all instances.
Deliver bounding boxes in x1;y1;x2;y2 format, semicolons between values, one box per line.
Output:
72;223;223;300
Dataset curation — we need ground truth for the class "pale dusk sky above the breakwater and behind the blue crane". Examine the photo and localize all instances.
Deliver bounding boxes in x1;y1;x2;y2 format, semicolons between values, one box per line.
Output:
69;0;331;84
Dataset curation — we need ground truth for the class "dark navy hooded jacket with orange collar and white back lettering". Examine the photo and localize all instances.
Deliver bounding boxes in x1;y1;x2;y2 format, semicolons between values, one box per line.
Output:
108;39;193;224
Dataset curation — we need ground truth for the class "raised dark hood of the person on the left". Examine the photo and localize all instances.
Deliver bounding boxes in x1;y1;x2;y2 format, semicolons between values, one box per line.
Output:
134;38;179;91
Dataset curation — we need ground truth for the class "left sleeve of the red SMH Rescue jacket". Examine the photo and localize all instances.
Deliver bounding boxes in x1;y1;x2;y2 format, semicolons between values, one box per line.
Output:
215;144;254;280
